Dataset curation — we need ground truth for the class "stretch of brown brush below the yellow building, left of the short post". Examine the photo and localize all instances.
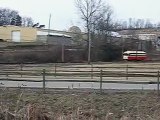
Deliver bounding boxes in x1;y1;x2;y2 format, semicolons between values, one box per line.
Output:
0;47;61;63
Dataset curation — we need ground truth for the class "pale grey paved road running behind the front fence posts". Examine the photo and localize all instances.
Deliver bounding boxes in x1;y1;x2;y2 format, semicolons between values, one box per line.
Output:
0;81;157;90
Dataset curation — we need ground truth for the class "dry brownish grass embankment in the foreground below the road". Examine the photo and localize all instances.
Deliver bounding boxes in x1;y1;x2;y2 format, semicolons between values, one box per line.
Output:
0;89;160;120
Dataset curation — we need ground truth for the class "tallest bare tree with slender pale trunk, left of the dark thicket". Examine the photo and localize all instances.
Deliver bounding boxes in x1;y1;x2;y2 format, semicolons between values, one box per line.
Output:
75;0;110;63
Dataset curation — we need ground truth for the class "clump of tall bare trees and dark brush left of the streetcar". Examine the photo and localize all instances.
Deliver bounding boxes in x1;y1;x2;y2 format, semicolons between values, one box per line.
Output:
75;0;124;63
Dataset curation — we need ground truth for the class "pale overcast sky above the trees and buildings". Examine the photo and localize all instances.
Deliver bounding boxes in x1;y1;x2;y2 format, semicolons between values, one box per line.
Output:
0;0;160;30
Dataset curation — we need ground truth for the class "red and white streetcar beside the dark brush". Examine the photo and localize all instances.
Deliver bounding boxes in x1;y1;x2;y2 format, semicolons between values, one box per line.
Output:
123;51;148;61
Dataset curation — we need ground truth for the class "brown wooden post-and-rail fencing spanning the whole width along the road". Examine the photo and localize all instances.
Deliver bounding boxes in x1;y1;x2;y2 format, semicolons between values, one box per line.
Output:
0;63;159;94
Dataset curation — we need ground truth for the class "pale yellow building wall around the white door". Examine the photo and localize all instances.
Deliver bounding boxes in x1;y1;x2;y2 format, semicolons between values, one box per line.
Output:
0;26;37;42
